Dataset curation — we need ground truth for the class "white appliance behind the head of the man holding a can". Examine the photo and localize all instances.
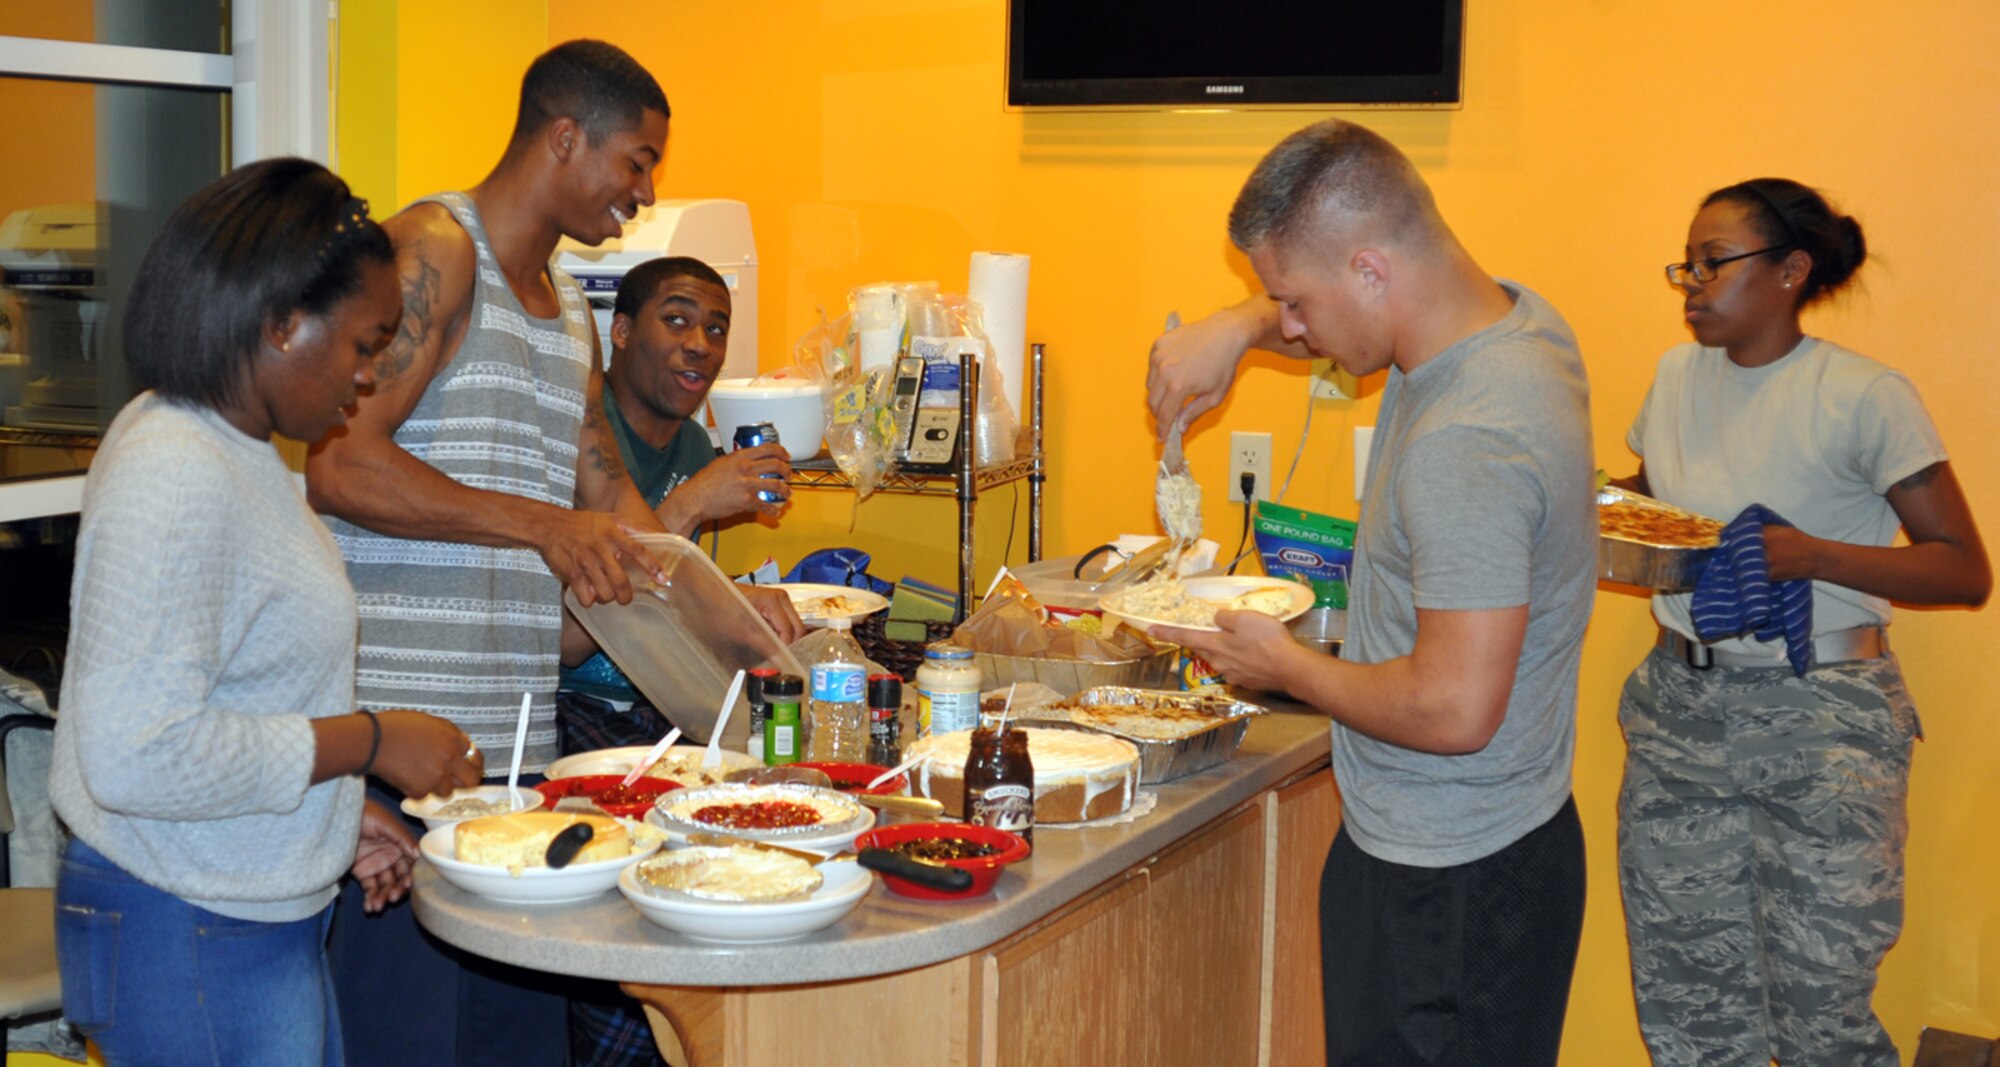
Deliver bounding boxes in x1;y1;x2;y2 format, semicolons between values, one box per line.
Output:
556;198;758;378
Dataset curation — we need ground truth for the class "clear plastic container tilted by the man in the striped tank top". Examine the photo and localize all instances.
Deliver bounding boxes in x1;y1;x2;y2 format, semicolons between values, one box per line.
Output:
562;534;806;751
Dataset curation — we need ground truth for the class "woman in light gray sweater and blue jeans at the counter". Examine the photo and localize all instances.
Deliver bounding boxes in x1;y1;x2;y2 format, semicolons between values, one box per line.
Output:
50;160;482;1067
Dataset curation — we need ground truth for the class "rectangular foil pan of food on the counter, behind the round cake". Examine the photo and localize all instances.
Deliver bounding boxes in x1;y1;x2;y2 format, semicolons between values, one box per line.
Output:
1024;685;1266;785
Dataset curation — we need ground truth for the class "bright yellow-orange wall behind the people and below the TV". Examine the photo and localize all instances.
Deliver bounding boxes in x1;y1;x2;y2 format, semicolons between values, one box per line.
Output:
328;0;2000;1065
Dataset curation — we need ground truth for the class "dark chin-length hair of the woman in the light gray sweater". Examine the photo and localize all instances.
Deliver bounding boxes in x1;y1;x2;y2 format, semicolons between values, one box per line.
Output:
124;158;396;408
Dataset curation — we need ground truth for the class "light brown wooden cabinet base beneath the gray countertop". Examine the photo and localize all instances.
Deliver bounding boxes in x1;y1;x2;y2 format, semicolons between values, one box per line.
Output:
626;769;1340;1067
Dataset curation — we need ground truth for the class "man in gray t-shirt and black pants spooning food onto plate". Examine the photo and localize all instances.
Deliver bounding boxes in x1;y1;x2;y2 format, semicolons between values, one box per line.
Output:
1148;120;1596;1065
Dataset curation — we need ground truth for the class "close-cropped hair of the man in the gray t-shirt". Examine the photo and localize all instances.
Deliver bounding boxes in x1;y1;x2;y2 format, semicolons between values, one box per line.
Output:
1230;118;1442;252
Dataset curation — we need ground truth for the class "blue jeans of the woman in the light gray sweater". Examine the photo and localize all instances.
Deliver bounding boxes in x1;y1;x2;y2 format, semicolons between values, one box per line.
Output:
56;839;346;1067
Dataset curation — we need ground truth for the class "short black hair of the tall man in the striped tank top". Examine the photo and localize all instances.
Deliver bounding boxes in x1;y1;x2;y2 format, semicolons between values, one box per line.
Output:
514;40;672;144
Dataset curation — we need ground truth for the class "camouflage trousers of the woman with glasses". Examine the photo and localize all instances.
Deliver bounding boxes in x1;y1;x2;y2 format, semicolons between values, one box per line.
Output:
1618;649;1918;1067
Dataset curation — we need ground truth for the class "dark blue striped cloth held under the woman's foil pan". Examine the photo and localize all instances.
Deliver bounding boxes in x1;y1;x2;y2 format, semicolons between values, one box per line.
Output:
1692;504;1812;675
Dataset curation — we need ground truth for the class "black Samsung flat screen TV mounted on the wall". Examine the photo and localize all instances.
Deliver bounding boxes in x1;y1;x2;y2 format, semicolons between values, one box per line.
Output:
1006;0;1464;108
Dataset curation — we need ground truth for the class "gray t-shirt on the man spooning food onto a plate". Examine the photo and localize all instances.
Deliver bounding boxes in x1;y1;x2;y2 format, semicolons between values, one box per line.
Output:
1334;282;1598;867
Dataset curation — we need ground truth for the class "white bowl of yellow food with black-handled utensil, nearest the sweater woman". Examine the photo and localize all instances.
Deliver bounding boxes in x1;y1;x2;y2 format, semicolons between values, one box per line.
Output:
418;811;660;903
